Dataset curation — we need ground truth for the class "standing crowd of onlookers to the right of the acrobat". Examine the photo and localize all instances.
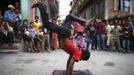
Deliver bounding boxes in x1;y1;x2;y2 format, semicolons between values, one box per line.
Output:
77;16;134;52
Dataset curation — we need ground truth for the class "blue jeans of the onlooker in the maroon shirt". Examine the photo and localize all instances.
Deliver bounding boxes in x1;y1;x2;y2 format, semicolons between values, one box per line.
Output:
97;34;106;49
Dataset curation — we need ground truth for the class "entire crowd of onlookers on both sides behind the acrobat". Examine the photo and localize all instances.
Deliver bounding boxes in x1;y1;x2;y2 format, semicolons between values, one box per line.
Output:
0;5;134;52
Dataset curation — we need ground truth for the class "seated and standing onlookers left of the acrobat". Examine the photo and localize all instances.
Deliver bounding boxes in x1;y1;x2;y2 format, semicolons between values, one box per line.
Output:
0;5;57;52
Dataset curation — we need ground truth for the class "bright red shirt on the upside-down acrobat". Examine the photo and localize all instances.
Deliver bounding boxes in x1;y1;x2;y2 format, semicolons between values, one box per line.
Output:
63;40;82;62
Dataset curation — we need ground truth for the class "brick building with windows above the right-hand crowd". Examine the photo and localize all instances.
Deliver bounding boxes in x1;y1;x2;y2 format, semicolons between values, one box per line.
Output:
70;0;134;19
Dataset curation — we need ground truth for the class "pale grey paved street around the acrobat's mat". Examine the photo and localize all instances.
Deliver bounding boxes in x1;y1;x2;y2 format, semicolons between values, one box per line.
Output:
0;50;134;75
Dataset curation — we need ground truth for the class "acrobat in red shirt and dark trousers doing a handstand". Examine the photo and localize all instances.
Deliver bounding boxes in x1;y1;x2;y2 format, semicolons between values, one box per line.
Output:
32;2;93;75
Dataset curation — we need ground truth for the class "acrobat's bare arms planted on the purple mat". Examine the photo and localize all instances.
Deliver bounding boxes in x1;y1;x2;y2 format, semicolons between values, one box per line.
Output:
66;57;75;75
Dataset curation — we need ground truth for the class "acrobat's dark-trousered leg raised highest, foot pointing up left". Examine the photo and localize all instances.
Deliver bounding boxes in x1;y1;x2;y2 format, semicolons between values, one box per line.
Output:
33;2;71;38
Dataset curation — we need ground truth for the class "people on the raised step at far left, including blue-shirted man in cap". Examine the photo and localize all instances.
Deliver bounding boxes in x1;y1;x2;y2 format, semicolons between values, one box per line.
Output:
0;5;22;47
